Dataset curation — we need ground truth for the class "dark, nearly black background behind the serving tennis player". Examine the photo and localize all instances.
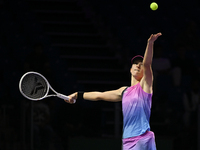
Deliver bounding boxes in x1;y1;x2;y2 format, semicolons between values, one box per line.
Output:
0;0;200;150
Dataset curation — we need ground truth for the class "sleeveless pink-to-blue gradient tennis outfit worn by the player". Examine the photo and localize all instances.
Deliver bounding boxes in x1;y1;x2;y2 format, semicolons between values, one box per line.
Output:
122;83;156;150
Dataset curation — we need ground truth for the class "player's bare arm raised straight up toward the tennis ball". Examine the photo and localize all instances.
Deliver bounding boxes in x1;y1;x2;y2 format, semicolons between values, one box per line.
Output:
140;33;162;93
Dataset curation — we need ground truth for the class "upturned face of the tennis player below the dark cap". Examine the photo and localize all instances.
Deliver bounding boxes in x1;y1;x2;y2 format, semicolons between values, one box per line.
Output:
130;61;143;80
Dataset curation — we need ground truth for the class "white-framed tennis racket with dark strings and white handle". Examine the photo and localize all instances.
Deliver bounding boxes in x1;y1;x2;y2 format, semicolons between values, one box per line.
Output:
19;72;76;103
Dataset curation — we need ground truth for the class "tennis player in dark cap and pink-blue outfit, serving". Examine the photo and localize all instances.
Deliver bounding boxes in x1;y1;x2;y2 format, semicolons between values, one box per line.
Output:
65;33;162;150
